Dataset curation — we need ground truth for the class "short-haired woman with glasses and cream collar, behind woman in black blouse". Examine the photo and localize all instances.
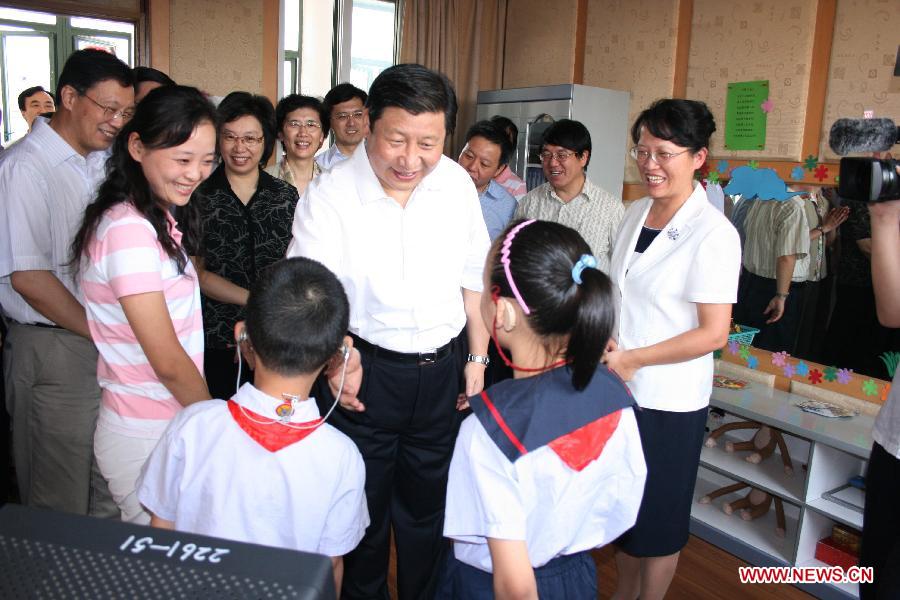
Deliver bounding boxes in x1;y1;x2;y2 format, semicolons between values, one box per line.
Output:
266;94;329;194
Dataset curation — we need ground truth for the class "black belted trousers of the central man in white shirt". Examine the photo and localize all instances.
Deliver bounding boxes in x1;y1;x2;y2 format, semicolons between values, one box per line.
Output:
316;338;462;600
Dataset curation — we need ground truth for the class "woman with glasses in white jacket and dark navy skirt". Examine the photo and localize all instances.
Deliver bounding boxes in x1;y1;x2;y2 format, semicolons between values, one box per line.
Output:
604;100;741;600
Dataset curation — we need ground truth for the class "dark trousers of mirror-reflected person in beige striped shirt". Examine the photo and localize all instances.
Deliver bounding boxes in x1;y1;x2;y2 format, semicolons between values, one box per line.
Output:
734;269;806;354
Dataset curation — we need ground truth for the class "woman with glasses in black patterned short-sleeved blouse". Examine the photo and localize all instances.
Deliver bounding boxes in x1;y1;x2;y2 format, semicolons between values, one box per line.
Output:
192;92;299;398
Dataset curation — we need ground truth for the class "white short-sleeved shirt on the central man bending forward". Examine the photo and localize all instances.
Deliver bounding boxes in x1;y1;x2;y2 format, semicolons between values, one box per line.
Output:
287;145;489;352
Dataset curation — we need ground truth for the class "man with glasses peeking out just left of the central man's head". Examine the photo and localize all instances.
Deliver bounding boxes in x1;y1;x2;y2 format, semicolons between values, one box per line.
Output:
316;83;369;170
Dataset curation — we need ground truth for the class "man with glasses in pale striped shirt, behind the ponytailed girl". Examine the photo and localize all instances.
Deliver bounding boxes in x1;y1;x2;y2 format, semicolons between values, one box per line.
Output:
515;119;625;273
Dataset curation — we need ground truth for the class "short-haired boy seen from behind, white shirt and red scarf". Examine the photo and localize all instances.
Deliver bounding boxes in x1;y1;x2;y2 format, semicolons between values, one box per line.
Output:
138;258;369;595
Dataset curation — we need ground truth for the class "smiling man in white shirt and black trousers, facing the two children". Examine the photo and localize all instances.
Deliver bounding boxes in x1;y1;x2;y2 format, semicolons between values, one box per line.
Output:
288;65;488;599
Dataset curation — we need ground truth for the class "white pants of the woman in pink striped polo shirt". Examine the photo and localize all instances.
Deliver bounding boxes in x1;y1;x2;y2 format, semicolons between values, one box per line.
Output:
94;419;162;525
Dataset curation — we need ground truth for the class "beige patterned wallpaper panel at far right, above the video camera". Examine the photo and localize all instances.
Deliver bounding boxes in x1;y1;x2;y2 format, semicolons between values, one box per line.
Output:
819;0;900;160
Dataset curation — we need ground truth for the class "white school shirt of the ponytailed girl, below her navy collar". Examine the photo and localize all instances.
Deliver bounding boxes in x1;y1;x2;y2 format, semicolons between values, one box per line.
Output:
444;408;647;573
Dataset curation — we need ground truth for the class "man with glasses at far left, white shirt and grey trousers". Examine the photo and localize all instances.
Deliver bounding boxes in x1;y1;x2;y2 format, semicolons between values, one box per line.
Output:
0;50;134;516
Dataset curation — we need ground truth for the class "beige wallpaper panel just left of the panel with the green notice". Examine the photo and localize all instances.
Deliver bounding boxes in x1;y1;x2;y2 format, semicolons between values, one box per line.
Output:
584;0;678;183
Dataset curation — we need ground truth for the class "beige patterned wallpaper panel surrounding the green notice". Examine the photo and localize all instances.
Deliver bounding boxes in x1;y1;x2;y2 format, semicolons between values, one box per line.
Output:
687;0;820;160
